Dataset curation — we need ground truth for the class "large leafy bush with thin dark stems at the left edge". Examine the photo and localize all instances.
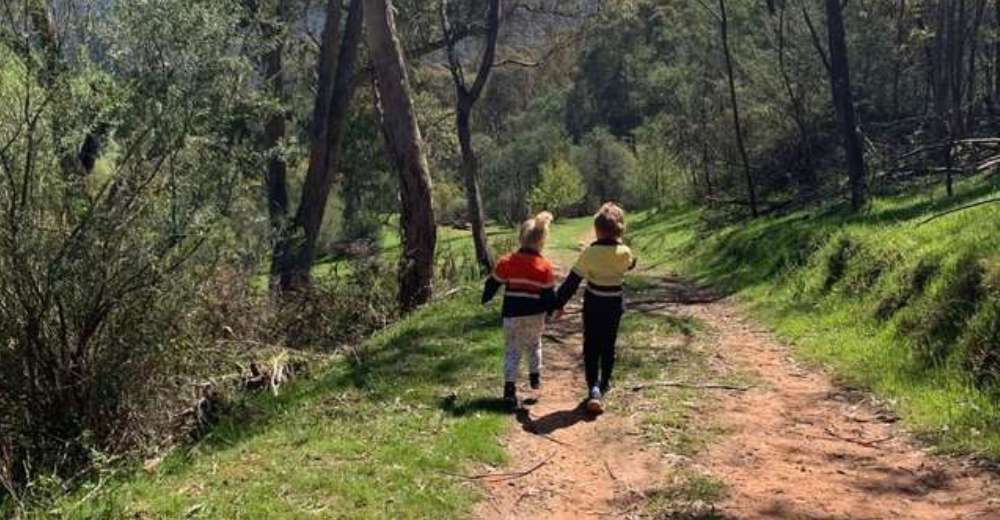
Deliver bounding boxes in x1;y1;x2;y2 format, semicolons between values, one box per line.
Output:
0;0;260;504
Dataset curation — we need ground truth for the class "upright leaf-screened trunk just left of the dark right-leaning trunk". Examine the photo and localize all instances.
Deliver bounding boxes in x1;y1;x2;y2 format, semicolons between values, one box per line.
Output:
262;1;289;288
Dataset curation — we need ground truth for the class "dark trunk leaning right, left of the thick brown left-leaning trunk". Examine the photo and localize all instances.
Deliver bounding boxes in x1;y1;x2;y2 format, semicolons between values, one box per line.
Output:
281;0;364;289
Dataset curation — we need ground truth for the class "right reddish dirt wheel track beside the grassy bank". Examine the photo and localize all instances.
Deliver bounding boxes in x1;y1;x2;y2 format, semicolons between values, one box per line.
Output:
684;286;1000;520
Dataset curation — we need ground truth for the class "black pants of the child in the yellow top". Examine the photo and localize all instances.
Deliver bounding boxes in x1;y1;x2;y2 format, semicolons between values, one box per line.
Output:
583;292;624;389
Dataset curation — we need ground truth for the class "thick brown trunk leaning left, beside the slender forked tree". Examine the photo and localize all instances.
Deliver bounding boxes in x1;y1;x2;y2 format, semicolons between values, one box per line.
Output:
364;0;437;311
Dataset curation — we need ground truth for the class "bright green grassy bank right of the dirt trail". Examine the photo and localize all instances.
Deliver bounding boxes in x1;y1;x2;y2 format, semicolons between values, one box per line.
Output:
631;177;1000;458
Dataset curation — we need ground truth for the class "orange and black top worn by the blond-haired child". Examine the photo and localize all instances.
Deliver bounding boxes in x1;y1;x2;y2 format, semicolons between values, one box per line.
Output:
483;248;556;318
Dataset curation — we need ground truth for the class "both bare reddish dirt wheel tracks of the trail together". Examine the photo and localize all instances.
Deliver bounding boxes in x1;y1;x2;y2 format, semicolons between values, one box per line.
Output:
477;255;1000;520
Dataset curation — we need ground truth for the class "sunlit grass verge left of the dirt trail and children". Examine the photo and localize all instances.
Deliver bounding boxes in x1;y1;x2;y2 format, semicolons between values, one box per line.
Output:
45;291;509;518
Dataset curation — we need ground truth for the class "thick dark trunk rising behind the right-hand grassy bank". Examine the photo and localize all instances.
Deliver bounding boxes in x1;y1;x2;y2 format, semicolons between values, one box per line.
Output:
826;0;867;211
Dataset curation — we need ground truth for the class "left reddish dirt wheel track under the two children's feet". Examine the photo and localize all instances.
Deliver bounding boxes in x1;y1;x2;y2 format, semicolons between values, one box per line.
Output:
477;292;665;520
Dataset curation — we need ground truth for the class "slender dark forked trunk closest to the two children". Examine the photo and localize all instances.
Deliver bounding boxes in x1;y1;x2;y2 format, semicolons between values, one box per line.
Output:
441;0;501;272
